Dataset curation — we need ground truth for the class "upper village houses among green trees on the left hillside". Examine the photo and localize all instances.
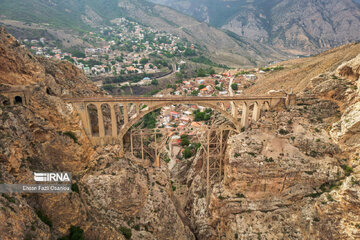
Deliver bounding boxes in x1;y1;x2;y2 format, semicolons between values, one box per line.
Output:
22;18;194;76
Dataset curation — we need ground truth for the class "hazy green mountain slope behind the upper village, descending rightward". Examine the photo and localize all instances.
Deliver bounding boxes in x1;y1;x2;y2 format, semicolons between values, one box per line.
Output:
0;0;288;66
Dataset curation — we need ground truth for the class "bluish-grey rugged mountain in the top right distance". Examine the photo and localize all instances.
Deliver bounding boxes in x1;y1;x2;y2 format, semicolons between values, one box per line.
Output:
151;0;360;54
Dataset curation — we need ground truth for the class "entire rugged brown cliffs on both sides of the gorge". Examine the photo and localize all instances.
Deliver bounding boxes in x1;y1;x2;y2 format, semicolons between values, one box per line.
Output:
0;26;360;239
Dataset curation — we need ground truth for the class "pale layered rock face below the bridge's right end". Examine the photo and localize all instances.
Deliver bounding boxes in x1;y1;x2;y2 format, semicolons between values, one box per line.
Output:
177;99;360;239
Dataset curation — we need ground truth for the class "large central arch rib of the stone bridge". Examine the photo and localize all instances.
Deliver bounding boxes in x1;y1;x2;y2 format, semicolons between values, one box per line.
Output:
119;102;241;138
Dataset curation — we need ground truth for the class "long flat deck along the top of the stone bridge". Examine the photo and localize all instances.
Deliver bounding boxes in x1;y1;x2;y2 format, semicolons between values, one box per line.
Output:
64;95;286;103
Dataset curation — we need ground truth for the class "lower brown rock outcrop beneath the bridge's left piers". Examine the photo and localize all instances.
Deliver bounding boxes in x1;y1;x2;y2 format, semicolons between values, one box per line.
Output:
80;149;195;239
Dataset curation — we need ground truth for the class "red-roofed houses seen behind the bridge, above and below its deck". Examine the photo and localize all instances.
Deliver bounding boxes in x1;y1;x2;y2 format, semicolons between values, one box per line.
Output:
151;69;262;155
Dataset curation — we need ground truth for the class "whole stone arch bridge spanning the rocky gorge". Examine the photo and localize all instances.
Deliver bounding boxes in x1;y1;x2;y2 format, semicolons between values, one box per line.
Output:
65;94;296;145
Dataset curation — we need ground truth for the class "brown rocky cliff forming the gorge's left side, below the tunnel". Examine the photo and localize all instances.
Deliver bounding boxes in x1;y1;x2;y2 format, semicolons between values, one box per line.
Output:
0;28;194;240
